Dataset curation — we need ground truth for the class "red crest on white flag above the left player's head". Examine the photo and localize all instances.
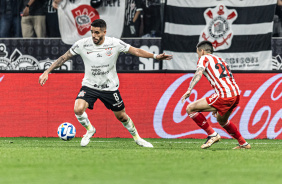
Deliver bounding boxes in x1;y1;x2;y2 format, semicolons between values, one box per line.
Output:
71;4;100;36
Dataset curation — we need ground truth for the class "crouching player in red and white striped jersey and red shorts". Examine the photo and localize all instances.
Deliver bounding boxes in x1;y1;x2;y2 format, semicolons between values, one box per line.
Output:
181;41;251;149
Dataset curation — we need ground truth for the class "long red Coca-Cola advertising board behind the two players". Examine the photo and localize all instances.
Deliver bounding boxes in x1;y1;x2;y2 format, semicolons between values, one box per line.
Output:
0;73;282;139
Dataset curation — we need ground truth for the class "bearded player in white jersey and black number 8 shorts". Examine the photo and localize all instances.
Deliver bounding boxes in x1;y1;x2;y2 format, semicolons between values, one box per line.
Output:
39;19;172;147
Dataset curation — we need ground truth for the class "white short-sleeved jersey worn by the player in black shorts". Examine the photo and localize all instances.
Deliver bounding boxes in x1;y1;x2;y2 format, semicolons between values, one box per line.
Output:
70;36;130;91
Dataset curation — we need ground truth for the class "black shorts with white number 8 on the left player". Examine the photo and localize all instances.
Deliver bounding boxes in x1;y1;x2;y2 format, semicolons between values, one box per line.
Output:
76;86;124;111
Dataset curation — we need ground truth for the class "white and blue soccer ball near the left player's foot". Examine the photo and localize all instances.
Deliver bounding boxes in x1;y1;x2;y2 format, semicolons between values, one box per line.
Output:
58;122;76;141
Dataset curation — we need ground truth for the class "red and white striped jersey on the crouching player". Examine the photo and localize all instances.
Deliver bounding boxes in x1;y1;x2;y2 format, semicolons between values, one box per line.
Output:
197;54;240;98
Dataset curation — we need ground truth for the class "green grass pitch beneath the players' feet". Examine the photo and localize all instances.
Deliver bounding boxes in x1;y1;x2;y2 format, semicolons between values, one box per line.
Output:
0;138;282;184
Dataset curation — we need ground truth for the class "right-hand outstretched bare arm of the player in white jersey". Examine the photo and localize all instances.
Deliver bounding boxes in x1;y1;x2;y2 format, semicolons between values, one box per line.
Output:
128;46;172;60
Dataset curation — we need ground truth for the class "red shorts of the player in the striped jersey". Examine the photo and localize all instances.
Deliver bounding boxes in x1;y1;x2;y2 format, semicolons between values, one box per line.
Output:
206;93;240;116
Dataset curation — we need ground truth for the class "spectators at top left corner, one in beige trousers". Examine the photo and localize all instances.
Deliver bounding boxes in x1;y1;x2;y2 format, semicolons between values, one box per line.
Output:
0;0;60;38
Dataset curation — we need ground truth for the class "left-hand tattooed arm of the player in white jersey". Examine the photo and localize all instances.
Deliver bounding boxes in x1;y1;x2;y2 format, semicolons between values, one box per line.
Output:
38;50;73;86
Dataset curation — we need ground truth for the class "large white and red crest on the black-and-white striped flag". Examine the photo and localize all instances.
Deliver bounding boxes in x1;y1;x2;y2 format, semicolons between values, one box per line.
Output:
199;5;238;51
